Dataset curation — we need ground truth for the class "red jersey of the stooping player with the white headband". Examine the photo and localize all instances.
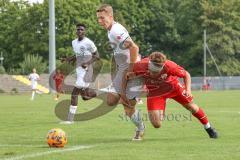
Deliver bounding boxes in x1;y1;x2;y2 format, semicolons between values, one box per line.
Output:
133;58;186;96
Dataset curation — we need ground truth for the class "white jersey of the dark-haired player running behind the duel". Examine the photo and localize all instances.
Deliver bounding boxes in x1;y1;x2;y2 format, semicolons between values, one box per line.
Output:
72;37;97;66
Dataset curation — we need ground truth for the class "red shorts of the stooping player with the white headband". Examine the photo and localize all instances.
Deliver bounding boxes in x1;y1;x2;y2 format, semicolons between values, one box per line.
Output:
147;86;193;111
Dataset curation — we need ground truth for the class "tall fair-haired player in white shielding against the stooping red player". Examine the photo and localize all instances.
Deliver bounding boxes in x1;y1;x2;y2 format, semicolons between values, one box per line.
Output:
97;4;145;140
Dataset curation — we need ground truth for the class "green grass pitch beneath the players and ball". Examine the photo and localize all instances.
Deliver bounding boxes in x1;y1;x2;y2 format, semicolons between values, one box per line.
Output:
0;91;240;160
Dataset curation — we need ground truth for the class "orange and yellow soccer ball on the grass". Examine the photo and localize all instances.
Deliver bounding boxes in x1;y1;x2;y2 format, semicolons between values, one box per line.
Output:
47;128;67;147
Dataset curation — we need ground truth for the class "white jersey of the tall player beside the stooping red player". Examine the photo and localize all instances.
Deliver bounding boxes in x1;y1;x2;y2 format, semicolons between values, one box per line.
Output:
108;22;140;70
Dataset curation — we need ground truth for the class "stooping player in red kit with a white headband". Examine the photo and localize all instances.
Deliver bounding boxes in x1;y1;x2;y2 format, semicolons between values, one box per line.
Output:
122;52;218;138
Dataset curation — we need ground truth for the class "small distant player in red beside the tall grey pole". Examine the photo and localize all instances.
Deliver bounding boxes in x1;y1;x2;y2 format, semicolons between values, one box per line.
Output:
53;69;64;100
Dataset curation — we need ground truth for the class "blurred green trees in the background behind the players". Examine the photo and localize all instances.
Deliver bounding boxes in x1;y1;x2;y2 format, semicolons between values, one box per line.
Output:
0;0;240;76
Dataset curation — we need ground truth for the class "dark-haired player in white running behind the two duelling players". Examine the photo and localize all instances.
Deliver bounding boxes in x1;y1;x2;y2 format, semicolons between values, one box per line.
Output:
62;24;99;124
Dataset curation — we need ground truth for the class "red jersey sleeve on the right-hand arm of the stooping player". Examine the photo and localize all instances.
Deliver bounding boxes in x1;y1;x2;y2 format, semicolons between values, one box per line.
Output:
168;61;186;78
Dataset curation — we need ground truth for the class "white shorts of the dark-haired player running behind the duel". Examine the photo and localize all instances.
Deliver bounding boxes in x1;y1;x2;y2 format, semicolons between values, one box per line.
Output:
75;67;91;88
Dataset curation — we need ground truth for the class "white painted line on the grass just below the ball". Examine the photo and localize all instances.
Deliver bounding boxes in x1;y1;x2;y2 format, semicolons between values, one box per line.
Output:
0;145;93;160
